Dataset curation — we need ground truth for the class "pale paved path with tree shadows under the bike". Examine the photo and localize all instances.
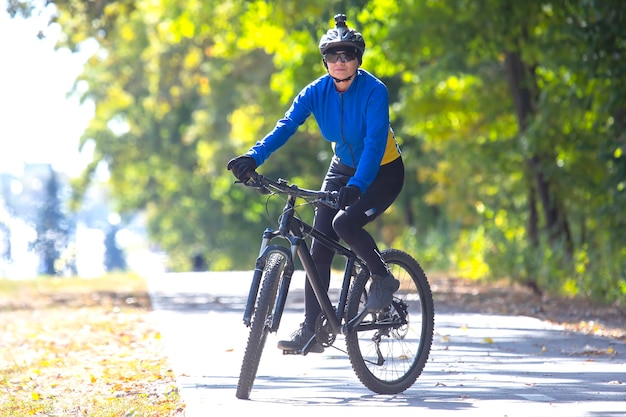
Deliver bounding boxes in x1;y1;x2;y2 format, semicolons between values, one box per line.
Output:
148;272;626;417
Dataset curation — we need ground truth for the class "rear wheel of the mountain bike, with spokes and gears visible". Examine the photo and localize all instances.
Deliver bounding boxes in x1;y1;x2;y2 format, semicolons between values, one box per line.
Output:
346;249;435;394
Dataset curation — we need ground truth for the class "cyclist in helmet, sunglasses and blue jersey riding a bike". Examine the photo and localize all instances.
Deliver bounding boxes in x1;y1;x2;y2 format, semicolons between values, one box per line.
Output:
227;14;404;353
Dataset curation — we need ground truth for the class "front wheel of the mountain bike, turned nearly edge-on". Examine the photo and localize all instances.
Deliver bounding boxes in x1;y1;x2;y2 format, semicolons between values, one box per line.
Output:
236;252;287;400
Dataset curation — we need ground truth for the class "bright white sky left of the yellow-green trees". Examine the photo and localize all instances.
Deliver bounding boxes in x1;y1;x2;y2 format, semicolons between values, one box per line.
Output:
0;0;93;176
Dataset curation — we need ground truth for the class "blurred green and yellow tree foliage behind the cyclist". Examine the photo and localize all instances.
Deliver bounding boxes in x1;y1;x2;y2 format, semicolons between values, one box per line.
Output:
10;0;626;302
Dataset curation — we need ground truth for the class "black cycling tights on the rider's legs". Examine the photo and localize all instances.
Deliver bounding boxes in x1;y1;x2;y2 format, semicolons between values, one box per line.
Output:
304;158;404;329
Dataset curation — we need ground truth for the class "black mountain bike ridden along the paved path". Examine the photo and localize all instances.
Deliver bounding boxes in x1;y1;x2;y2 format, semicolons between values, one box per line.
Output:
236;172;435;399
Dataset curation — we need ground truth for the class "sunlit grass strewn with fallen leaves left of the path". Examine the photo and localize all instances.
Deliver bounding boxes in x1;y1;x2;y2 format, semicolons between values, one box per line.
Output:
0;275;184;417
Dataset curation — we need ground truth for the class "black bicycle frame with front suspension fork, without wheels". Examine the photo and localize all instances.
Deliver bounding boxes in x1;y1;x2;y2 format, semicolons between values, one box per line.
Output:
244;188;367;342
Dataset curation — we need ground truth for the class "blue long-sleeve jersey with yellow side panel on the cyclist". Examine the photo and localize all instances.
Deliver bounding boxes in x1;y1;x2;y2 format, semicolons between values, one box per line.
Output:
247;69;400;192
